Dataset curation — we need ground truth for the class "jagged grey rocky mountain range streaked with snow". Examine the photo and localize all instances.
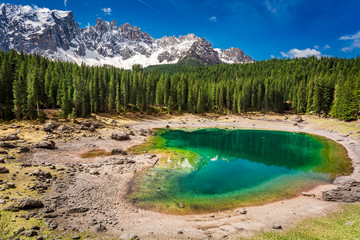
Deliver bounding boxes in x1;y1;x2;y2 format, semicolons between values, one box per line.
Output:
0;3;254;69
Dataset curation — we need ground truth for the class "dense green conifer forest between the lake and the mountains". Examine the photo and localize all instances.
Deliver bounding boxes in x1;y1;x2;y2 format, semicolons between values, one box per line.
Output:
0;50;360;121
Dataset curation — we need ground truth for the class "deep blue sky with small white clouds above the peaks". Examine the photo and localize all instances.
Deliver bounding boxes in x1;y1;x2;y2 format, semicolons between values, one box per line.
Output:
5;0;360;60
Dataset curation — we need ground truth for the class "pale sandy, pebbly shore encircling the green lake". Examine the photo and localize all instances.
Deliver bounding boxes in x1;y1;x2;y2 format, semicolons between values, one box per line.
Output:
0;115;360;239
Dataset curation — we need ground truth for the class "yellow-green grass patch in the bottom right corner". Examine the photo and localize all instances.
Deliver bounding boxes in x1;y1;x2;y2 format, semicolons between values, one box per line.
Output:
244;203;360;240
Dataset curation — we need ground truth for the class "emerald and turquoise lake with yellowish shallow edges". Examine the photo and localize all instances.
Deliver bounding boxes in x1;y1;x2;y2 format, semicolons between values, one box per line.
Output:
129;128;352;213
